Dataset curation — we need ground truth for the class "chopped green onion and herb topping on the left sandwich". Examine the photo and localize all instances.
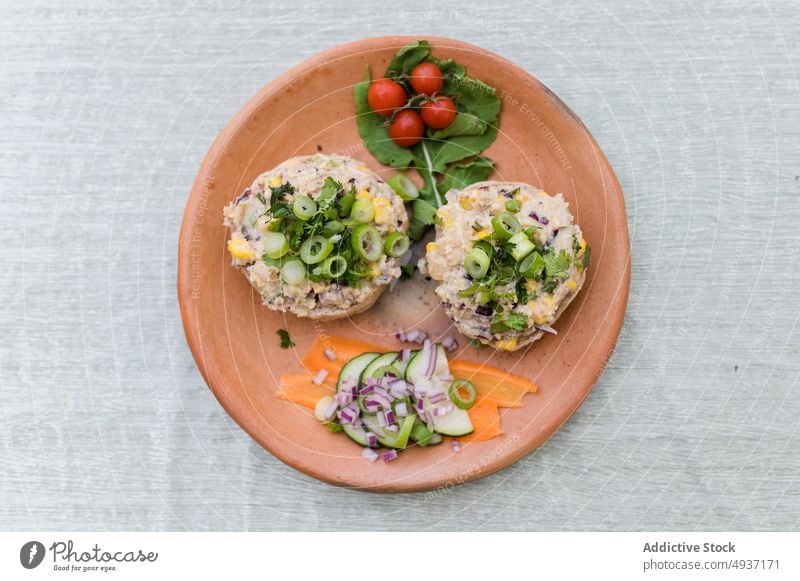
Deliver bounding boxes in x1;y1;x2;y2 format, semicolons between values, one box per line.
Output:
261;177;409;287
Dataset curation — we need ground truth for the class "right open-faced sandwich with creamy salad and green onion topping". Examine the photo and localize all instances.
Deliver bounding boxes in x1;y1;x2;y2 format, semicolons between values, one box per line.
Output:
427;182;589;351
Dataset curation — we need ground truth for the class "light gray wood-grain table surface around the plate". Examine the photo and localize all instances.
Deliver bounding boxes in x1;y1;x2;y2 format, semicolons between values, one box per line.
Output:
0;0;800;530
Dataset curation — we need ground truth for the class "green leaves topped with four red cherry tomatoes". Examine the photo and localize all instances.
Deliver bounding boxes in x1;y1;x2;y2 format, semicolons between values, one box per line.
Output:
355;40;500;240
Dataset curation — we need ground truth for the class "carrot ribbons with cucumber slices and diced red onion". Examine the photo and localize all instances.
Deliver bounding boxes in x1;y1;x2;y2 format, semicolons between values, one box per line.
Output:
278;336;537;461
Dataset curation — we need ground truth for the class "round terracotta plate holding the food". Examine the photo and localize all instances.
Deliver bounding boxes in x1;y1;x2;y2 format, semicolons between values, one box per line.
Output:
178;37;630;491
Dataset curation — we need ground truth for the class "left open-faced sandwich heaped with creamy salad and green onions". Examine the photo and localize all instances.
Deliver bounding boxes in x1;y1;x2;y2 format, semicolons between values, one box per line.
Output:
224;154;409;320
